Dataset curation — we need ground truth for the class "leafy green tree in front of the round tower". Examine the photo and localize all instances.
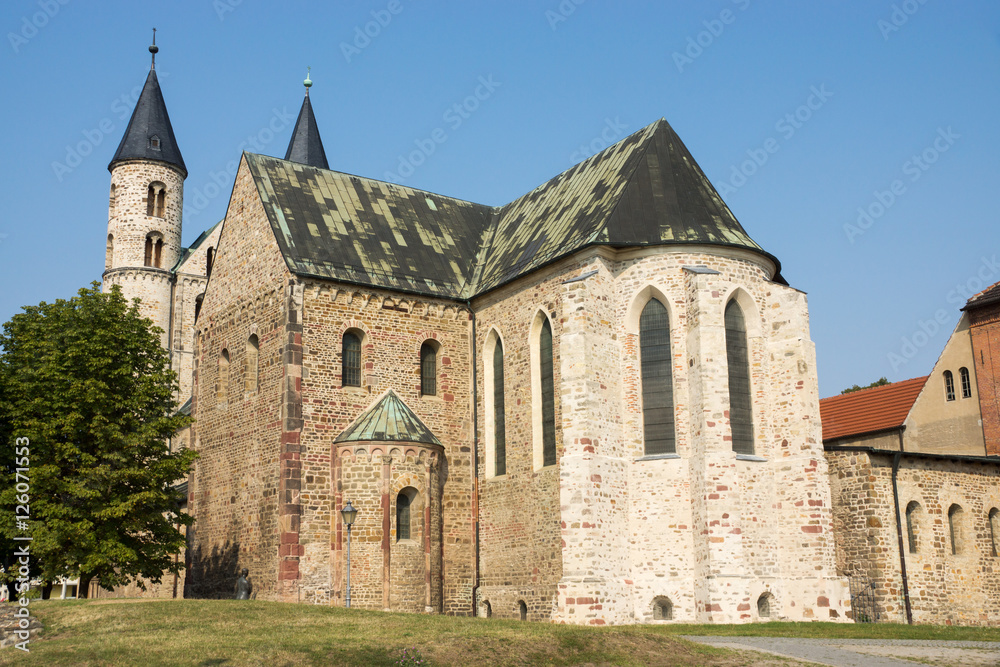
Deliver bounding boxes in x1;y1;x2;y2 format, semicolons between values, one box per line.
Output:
0;283;196;596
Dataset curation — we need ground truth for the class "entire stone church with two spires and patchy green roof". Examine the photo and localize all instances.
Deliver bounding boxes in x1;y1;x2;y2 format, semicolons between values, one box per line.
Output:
104;47;850;625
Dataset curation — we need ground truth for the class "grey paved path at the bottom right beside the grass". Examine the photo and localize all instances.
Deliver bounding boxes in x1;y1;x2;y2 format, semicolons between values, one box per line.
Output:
684;636;1000;667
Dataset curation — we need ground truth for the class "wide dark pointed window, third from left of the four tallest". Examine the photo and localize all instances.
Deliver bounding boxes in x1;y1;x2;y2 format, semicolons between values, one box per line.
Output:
639;299;677;455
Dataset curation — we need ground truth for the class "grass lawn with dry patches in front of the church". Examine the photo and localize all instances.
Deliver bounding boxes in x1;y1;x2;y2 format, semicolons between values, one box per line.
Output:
0;600;1000;667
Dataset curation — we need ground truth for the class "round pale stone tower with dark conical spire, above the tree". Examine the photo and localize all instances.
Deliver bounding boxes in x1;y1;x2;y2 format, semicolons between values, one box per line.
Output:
104;29;187;347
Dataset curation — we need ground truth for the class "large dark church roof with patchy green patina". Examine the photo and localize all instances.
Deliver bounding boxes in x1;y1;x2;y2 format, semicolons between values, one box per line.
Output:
246;119;785;299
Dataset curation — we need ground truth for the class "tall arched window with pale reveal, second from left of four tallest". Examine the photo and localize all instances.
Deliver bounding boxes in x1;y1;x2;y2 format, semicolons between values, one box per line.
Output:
528;310;556;470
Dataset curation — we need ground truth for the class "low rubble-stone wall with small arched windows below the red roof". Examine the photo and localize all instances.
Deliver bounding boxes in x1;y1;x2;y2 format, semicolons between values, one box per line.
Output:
827;451;1000;625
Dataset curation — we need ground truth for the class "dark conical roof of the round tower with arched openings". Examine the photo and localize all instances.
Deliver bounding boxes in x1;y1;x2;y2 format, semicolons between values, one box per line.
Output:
108;69;187;178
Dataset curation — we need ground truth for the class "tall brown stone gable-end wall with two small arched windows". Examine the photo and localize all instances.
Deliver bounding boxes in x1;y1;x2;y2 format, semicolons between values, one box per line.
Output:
185;159;291;599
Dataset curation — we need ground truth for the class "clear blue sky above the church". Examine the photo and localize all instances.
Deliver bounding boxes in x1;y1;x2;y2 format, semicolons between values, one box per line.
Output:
0;0;1000;396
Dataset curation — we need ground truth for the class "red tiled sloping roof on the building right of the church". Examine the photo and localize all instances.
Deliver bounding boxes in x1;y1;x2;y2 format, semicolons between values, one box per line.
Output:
819;375;927;442
